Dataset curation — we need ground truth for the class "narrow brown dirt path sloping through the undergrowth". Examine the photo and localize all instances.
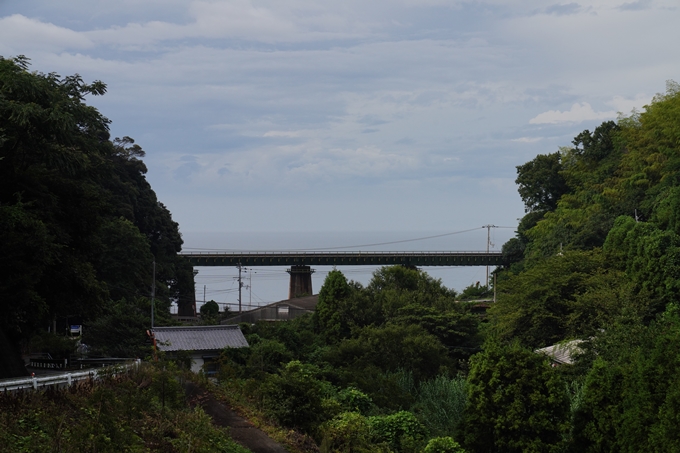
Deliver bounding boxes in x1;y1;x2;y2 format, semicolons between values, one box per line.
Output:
185;382;288;453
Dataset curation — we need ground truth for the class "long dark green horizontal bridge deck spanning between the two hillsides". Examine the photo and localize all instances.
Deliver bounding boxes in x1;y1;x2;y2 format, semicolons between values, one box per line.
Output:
181;252;503;267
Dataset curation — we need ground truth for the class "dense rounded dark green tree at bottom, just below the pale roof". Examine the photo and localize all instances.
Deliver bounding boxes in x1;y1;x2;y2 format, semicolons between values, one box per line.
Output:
464;340;569;453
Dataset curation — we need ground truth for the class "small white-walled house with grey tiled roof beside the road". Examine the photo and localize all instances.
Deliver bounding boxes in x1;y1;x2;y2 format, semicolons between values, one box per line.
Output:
151;325;248;374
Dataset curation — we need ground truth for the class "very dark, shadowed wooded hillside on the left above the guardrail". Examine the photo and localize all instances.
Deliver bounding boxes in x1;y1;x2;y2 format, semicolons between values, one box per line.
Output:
0;57;194;377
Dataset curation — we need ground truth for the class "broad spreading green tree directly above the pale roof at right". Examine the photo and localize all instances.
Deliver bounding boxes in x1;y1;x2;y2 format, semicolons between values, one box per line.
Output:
487;250;625;348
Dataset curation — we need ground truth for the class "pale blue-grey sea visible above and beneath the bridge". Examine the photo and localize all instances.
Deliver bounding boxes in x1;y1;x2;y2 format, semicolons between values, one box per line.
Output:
182;230;515;311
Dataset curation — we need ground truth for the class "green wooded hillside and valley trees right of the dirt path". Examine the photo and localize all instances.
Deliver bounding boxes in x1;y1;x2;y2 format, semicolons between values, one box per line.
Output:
209;83;680;453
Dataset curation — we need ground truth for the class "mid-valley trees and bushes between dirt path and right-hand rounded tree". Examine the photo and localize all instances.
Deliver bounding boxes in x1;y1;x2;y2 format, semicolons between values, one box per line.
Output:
212;266;481;452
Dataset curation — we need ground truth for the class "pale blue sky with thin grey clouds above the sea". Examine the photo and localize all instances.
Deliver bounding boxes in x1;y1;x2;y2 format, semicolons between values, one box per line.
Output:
0;0;680;304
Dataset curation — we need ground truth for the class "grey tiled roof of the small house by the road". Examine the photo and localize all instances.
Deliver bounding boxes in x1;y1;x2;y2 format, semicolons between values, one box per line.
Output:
152;325;248;351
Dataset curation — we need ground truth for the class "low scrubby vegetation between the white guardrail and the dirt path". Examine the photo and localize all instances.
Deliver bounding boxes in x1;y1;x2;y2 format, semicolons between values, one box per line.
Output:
0;364;248;453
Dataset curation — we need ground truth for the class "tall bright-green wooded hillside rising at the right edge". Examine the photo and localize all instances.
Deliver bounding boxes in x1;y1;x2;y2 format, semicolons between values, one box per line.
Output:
484;82;680;452
